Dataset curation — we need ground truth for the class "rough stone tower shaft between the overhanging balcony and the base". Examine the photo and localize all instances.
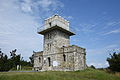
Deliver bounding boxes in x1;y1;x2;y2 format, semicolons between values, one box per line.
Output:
44;30;70;54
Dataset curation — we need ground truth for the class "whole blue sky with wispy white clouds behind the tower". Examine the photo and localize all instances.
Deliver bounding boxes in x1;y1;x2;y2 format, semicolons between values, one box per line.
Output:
0;0;120;68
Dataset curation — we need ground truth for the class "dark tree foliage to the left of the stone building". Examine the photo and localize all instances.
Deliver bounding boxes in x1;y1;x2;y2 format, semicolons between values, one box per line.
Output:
0;49;32;71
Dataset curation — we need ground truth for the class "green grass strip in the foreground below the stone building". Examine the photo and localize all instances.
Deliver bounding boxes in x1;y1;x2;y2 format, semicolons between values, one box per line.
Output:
0;69;120;80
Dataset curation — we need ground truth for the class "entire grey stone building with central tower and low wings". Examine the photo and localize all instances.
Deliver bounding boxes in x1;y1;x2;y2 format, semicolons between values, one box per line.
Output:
34;15;86;71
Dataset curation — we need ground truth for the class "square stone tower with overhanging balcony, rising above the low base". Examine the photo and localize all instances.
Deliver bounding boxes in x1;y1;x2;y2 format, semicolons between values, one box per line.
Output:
38;15;74;55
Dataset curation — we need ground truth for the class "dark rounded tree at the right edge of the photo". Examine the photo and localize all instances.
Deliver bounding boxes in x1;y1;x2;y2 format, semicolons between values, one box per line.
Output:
107;52;120;72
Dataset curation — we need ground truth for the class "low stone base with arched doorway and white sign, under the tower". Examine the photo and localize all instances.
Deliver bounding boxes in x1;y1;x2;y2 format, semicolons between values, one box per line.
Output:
33;46;86;71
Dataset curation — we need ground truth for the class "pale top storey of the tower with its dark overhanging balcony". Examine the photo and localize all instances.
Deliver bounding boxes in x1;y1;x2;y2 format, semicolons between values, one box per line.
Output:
38;15;74;36
